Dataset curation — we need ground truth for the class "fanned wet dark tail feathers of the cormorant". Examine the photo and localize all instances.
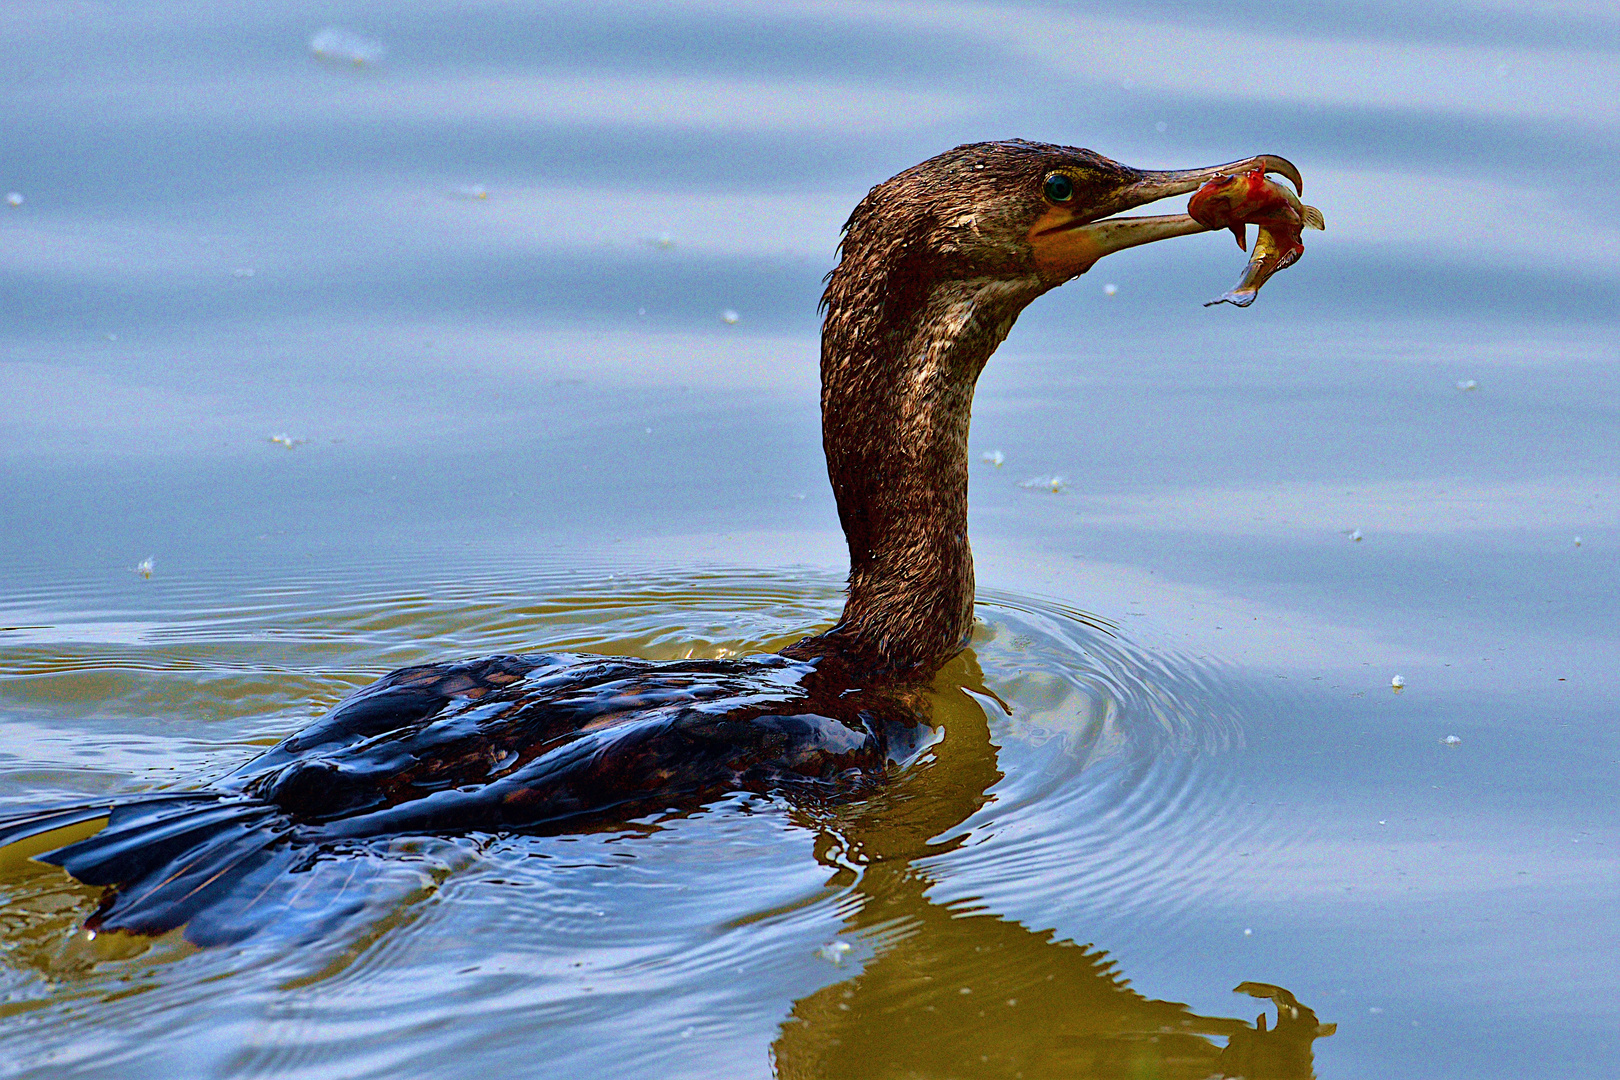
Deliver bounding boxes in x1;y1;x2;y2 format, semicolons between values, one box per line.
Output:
0;792;298;944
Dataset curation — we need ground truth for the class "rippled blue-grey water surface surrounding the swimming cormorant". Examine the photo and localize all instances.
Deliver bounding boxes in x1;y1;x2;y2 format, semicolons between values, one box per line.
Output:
0;3;1620;1077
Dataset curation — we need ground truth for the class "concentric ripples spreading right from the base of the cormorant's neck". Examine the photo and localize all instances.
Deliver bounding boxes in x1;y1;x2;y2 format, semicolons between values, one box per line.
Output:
935;594;1264;925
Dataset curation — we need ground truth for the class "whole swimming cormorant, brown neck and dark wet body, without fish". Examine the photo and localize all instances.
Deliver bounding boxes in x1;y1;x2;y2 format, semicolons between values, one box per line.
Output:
0;142;1298;941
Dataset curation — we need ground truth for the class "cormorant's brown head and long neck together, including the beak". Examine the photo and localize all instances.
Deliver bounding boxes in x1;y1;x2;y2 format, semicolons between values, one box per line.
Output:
784;139;1263;682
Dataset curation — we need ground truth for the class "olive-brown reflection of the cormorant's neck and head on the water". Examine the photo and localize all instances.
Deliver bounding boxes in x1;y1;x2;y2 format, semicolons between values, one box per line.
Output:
773;653;1337;1080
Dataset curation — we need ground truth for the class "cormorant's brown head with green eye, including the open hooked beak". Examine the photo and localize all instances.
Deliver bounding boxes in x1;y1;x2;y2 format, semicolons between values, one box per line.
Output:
842;139;1302;291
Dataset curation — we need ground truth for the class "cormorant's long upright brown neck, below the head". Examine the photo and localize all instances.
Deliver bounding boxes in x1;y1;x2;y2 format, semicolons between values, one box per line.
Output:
787;272;1045;678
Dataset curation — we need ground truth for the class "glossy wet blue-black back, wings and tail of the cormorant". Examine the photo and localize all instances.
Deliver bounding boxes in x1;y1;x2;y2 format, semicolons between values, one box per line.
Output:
0;656;920;944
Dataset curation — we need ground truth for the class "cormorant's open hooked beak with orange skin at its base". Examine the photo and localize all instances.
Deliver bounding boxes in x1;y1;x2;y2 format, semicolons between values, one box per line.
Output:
1029;154;1306;285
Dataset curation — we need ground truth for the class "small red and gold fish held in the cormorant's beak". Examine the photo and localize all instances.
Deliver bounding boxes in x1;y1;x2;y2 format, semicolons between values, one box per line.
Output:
1187;168;1327;308
